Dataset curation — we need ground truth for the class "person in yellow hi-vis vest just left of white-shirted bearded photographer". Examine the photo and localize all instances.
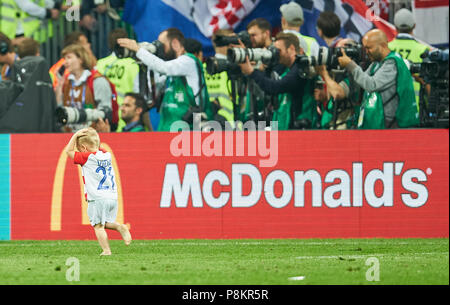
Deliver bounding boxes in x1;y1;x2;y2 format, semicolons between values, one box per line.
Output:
96;28;139;132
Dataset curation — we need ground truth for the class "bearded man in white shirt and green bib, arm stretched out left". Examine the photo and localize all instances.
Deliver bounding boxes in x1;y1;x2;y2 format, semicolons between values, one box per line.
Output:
118;28;212;131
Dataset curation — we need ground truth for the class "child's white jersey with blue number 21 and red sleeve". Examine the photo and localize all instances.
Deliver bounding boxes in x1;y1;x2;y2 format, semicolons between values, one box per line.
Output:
73;149;117;200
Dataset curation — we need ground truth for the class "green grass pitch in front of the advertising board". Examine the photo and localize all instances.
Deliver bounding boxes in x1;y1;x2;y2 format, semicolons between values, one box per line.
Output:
0;238;449;285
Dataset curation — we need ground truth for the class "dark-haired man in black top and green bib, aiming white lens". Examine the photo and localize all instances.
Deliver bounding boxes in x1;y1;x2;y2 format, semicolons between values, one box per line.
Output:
241;33;315;130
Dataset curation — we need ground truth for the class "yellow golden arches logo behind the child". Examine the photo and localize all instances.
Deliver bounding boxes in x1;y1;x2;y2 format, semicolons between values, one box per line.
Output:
50;143;123;231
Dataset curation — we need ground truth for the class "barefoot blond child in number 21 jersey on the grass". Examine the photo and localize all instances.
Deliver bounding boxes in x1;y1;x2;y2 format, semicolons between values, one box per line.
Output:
66;127;131;255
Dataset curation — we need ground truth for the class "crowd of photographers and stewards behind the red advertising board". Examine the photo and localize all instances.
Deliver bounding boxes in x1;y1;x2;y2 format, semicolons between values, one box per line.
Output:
0;0;444;132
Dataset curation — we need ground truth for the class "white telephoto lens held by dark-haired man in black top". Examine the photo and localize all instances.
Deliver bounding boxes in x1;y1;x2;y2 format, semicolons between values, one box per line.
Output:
227;46;280;67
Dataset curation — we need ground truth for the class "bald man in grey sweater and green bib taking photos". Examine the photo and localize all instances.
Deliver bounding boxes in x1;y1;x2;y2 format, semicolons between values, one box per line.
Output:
338;29;419;129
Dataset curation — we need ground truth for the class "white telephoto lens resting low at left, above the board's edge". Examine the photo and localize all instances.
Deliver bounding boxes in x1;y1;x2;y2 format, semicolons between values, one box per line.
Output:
55;106;112;125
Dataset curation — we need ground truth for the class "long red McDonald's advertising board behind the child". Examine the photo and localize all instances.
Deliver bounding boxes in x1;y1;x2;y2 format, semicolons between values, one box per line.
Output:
0;129;449;240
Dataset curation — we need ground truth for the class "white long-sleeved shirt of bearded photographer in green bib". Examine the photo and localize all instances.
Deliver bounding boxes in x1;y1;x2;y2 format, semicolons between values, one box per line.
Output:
136;48;200;105
